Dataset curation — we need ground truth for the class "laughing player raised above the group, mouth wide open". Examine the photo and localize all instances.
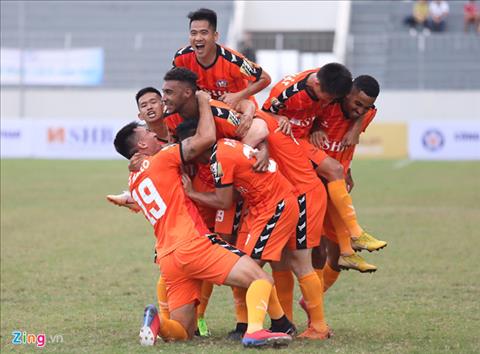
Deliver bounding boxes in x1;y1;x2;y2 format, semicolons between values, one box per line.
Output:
173;9;271;108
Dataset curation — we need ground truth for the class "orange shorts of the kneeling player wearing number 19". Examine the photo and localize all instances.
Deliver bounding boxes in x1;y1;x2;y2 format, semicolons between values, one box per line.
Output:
159;234;244;311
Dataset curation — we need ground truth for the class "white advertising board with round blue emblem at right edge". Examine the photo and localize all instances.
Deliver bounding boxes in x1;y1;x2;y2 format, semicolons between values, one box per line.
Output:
408;121;480;160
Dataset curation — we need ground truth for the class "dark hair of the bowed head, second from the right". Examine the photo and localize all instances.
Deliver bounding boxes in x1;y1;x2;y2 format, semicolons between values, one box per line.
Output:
317;63;352;98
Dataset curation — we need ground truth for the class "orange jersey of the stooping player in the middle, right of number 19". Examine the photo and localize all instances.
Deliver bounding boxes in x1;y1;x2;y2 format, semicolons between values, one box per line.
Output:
210;139;293;215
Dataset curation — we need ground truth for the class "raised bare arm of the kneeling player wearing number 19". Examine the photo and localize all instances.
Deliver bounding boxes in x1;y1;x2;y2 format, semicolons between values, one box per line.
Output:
181;90;216;162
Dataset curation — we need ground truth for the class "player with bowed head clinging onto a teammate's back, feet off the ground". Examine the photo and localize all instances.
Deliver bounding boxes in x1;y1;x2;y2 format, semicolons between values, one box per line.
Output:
262;63;386;271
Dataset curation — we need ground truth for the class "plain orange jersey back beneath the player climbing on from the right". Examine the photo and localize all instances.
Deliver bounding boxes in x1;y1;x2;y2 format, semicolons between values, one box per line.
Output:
255;110;323;195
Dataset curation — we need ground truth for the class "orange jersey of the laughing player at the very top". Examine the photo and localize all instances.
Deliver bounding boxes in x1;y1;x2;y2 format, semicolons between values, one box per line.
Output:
173;44;262;100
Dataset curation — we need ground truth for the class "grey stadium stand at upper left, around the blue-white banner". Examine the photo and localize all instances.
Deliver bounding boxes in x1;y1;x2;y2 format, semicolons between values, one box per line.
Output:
1;1;233;88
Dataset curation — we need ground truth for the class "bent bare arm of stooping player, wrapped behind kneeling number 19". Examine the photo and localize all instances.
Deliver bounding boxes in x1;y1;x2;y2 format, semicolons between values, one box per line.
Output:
182;174;234;210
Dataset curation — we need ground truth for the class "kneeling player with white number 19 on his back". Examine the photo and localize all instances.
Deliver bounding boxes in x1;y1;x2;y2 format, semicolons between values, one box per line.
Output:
114;91;291;346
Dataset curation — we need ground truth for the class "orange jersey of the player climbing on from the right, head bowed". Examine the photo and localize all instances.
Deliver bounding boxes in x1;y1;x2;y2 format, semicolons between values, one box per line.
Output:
262;69;328;138
